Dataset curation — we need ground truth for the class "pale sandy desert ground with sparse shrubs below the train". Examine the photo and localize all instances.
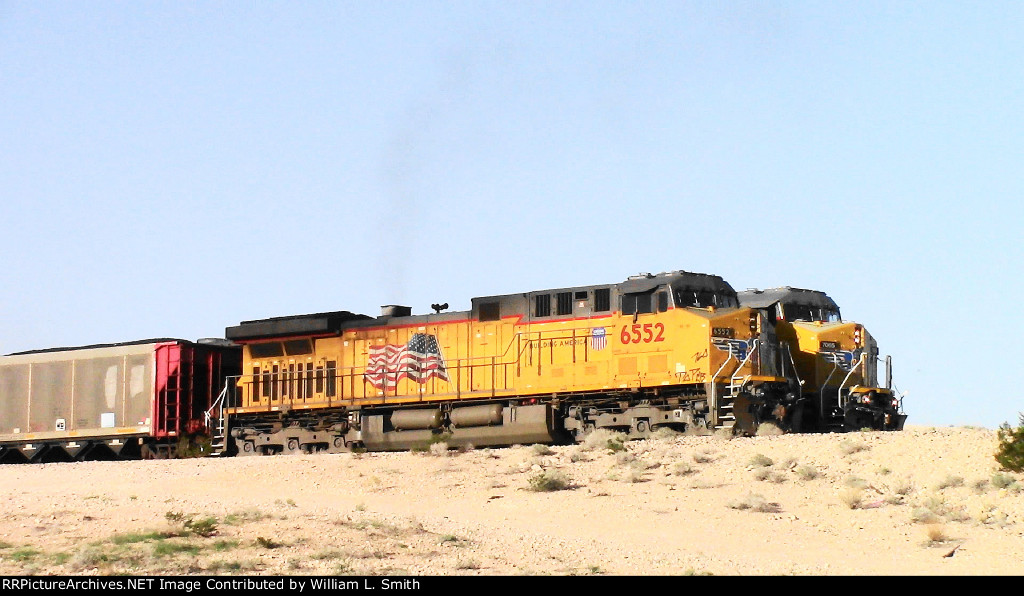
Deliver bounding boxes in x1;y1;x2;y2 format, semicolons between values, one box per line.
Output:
0;426;1024;576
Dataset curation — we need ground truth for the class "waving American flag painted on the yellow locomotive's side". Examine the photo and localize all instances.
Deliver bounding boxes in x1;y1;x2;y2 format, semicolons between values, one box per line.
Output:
362;333;449;389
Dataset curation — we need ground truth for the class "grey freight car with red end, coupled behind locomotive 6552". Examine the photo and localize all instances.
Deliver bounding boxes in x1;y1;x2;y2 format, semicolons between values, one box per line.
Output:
0;339;241;462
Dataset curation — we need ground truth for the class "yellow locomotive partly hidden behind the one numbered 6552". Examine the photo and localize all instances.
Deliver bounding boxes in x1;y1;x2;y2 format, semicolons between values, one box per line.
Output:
738;287;906;431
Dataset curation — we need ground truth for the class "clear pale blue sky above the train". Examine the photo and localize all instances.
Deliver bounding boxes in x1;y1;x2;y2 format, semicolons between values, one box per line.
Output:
0;0;1024;428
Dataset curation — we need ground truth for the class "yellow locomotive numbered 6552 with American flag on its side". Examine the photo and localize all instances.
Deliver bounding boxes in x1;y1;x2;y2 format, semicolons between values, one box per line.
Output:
220;271;800;455
